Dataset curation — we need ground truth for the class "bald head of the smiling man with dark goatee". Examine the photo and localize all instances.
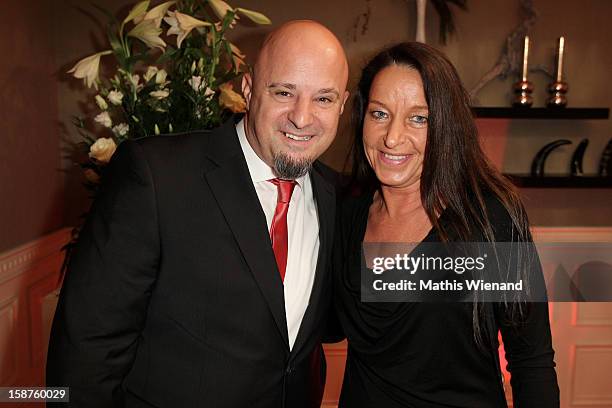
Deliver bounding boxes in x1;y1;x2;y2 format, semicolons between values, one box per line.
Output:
242;20;348;179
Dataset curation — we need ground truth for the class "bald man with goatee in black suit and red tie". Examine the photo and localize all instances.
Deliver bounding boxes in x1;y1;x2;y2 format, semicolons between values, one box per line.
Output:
47;21;348;408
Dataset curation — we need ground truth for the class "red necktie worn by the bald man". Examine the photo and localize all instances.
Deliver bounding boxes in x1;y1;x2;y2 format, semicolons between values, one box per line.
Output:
269;178;295;281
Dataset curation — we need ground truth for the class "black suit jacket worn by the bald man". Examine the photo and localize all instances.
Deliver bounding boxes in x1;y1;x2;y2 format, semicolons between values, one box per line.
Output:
47;121;335;408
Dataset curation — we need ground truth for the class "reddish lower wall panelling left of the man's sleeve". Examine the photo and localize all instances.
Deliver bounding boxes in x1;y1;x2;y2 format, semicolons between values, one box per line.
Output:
0;228;70;388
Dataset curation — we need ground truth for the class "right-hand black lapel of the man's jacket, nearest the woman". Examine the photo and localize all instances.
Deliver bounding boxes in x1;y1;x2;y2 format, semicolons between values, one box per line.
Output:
291;166;336;356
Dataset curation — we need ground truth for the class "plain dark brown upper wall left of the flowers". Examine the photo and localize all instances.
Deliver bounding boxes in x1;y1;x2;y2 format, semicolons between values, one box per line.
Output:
0;0;65;252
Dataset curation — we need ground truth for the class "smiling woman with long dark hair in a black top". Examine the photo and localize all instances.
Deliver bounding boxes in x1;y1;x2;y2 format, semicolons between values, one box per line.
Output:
335;43;559;408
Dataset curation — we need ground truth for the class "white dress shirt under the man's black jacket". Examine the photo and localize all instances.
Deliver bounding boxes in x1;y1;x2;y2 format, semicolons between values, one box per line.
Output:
236;119;319;349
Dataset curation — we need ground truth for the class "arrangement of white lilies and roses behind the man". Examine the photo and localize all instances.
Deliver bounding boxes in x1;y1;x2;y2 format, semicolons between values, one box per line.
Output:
62;0;270;272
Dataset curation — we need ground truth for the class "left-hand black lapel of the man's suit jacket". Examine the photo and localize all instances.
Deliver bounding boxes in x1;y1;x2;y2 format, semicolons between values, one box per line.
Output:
203;121;289;349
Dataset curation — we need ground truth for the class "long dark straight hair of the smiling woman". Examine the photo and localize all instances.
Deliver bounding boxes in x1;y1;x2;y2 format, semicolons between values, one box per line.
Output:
352;42;531;343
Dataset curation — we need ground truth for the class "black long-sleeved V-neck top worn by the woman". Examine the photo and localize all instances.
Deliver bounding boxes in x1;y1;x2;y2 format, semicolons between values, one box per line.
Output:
334;193;559;408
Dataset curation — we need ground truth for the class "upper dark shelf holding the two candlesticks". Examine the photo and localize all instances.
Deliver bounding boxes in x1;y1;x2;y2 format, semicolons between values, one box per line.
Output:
472;107;610;119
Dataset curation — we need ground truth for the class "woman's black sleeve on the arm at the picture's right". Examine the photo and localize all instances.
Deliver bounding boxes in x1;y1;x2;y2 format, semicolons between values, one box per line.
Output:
489;196;559;408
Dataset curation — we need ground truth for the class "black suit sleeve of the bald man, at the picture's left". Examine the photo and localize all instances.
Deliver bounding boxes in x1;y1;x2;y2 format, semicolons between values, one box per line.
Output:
47;141;160;408
